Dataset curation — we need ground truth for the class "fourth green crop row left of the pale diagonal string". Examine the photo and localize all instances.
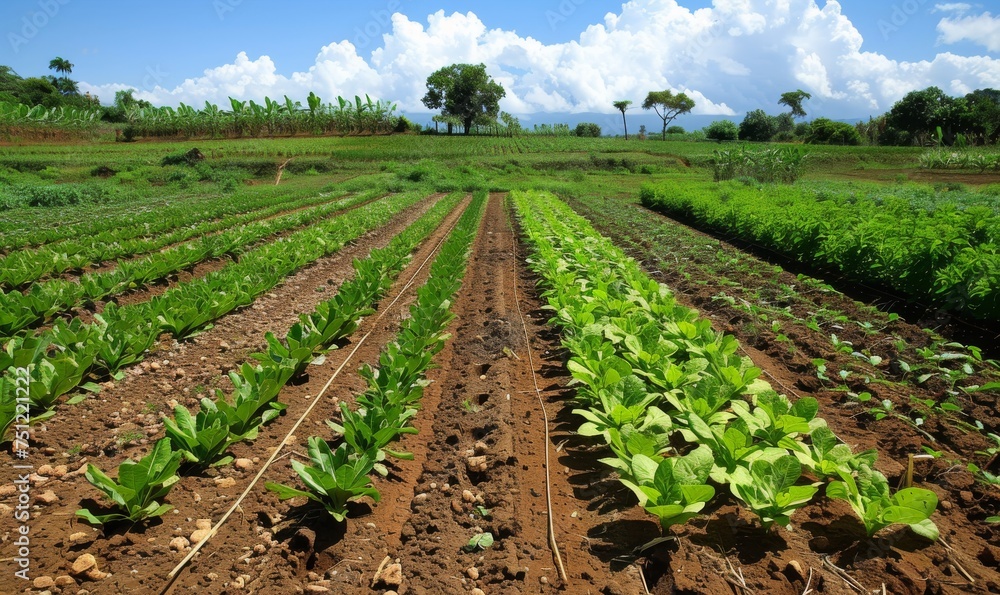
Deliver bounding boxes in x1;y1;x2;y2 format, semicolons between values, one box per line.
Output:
0;187;352;290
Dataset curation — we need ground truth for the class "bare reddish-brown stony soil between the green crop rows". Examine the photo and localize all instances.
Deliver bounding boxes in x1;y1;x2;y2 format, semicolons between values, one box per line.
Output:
0;196;1000;595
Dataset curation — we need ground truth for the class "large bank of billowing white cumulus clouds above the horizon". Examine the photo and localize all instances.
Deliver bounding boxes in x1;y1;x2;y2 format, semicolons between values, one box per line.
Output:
80;0;1000;117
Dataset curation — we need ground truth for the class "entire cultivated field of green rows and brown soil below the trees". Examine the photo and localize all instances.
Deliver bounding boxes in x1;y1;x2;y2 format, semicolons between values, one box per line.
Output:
0;135;1000;594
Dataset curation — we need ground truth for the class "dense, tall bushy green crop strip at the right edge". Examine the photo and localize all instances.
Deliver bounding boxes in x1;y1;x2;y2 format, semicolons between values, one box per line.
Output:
640;182;1000;321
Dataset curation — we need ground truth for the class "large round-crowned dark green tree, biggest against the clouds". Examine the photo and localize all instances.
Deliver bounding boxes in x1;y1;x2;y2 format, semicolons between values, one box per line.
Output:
422;64;507;134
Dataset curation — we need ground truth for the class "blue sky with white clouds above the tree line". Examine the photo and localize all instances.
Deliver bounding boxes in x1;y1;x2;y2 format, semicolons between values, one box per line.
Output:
0;0;1000;117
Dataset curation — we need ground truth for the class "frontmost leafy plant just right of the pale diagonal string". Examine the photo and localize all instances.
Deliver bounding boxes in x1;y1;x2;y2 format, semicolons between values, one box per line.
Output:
266;436;381;523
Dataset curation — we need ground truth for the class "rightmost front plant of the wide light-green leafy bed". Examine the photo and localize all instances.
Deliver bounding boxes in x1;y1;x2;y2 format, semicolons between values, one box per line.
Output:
826;464;939;541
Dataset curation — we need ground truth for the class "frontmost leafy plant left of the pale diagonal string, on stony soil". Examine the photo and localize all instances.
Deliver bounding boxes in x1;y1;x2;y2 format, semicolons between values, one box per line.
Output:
76;438;181;525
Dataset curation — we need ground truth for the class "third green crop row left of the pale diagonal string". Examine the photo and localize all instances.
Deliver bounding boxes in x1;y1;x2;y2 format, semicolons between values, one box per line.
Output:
0;192;377;337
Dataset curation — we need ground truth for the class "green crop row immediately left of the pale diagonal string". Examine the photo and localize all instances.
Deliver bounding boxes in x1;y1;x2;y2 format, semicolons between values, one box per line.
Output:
77;194;460;525
